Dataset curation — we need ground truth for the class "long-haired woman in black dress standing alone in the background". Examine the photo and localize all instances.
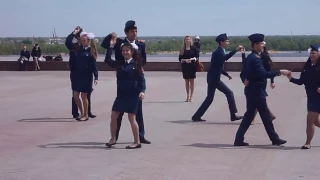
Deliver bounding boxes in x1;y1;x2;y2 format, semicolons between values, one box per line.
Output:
179;36;199;102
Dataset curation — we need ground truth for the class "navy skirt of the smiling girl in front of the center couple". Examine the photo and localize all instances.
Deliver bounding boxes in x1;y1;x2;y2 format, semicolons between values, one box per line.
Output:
112;94;139;114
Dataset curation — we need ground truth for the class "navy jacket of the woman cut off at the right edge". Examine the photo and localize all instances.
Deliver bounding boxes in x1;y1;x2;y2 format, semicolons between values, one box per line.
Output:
290;61;320;102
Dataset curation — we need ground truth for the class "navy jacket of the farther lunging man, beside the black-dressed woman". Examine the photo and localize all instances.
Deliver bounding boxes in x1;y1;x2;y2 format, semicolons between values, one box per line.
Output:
207;47;237;83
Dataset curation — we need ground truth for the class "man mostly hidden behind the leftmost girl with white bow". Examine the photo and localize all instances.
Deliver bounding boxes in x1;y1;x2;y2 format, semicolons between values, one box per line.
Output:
65;26;96;118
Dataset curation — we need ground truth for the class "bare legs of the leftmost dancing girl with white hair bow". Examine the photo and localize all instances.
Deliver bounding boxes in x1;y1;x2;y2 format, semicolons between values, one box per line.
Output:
73;91;88;121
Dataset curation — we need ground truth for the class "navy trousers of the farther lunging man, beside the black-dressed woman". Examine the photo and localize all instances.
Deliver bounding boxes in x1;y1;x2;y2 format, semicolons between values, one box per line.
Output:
193;81;238;118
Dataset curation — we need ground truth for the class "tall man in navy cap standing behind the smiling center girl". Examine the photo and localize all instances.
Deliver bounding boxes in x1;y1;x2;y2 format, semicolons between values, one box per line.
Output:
101;20;151;144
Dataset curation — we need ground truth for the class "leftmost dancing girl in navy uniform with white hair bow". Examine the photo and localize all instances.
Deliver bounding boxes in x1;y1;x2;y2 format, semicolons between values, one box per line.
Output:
68;28;98;121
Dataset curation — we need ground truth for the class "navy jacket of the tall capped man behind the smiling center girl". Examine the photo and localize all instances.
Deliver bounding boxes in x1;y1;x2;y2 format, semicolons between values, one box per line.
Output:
101;34;147;66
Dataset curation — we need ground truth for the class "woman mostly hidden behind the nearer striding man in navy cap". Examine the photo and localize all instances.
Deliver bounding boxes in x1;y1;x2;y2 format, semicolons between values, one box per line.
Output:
240;47;276;124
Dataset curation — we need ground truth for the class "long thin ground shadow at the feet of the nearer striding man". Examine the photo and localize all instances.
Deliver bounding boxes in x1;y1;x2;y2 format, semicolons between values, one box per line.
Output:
182;143;320;150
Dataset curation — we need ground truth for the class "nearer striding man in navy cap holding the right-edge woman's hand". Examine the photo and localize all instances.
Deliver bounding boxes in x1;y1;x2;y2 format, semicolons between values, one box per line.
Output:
234;33;290;146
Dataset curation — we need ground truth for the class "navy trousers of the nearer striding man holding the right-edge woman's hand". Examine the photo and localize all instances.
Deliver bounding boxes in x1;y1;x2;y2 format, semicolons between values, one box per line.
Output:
235;88;279;142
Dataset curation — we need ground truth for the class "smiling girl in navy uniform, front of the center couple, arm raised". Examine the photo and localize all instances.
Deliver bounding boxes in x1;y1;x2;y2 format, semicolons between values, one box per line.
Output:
105;42;146;149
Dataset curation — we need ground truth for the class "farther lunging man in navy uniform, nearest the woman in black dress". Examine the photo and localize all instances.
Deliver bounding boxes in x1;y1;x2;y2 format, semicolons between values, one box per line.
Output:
192;34;243;122
